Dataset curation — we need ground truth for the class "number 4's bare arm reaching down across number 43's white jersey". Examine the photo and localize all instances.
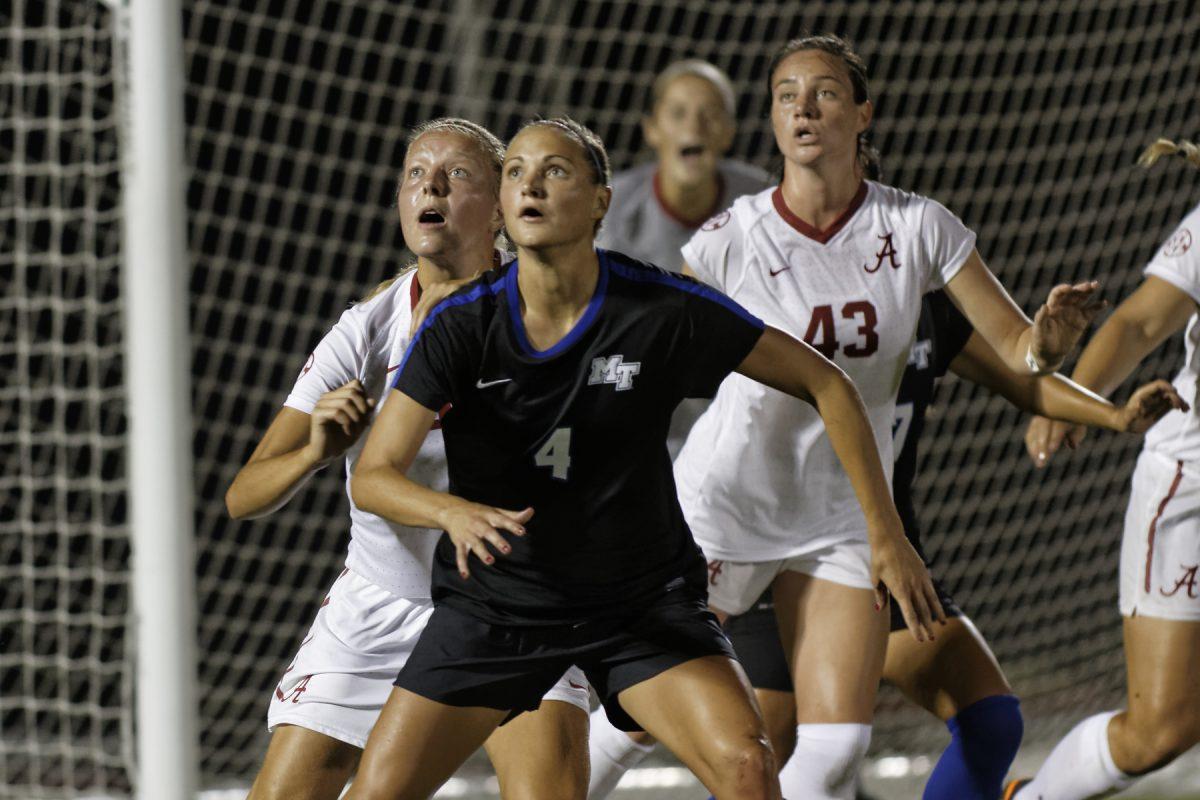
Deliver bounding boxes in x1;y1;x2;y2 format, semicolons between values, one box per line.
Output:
737;327;946;642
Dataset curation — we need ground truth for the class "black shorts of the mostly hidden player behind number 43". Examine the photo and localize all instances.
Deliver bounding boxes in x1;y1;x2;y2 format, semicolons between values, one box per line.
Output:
725;579;962;692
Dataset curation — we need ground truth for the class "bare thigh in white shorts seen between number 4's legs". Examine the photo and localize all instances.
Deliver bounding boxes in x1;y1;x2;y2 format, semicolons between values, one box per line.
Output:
485;700;588;800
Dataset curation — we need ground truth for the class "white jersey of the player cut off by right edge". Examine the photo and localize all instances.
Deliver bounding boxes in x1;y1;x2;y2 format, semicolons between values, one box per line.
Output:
1132;205;1200;462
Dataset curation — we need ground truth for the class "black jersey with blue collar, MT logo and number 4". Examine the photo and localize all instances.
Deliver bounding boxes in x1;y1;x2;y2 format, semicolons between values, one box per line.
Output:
395;249;763;625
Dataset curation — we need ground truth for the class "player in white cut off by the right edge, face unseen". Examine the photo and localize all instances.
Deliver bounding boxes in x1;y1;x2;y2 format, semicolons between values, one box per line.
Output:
1004;139;1200;800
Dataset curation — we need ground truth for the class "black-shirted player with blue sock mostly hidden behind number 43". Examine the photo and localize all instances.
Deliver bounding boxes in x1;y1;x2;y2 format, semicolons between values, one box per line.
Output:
588;291;1182;800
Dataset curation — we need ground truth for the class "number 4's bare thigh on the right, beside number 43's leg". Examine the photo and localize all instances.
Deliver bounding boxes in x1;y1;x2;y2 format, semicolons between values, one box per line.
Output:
619;656;779;787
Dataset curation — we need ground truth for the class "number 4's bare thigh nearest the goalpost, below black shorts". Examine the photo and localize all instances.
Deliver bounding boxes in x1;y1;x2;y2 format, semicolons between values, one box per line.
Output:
347;686;509;800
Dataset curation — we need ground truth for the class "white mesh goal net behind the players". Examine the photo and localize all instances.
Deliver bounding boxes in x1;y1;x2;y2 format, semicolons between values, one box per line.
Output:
7;0;1200;798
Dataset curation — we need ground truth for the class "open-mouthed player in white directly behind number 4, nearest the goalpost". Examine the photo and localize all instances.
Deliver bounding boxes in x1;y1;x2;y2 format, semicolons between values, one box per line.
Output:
226;119;588;800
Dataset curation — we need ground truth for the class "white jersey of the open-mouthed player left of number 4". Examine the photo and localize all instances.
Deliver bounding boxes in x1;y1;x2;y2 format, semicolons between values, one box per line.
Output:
284;269;449;599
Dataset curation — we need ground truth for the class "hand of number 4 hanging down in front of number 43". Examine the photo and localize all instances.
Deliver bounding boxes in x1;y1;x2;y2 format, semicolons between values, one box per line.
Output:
871;530;946;642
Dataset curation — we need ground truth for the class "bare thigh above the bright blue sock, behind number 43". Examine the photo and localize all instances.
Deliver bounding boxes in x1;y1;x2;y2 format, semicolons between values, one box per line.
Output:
883;616;1013;722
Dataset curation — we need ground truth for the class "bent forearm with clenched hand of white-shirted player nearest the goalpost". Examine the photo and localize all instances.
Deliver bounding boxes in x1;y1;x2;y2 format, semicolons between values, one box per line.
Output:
226;380;372;519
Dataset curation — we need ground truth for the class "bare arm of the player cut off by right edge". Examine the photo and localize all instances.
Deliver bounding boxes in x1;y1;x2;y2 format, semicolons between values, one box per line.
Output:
1025;276;1196;467
